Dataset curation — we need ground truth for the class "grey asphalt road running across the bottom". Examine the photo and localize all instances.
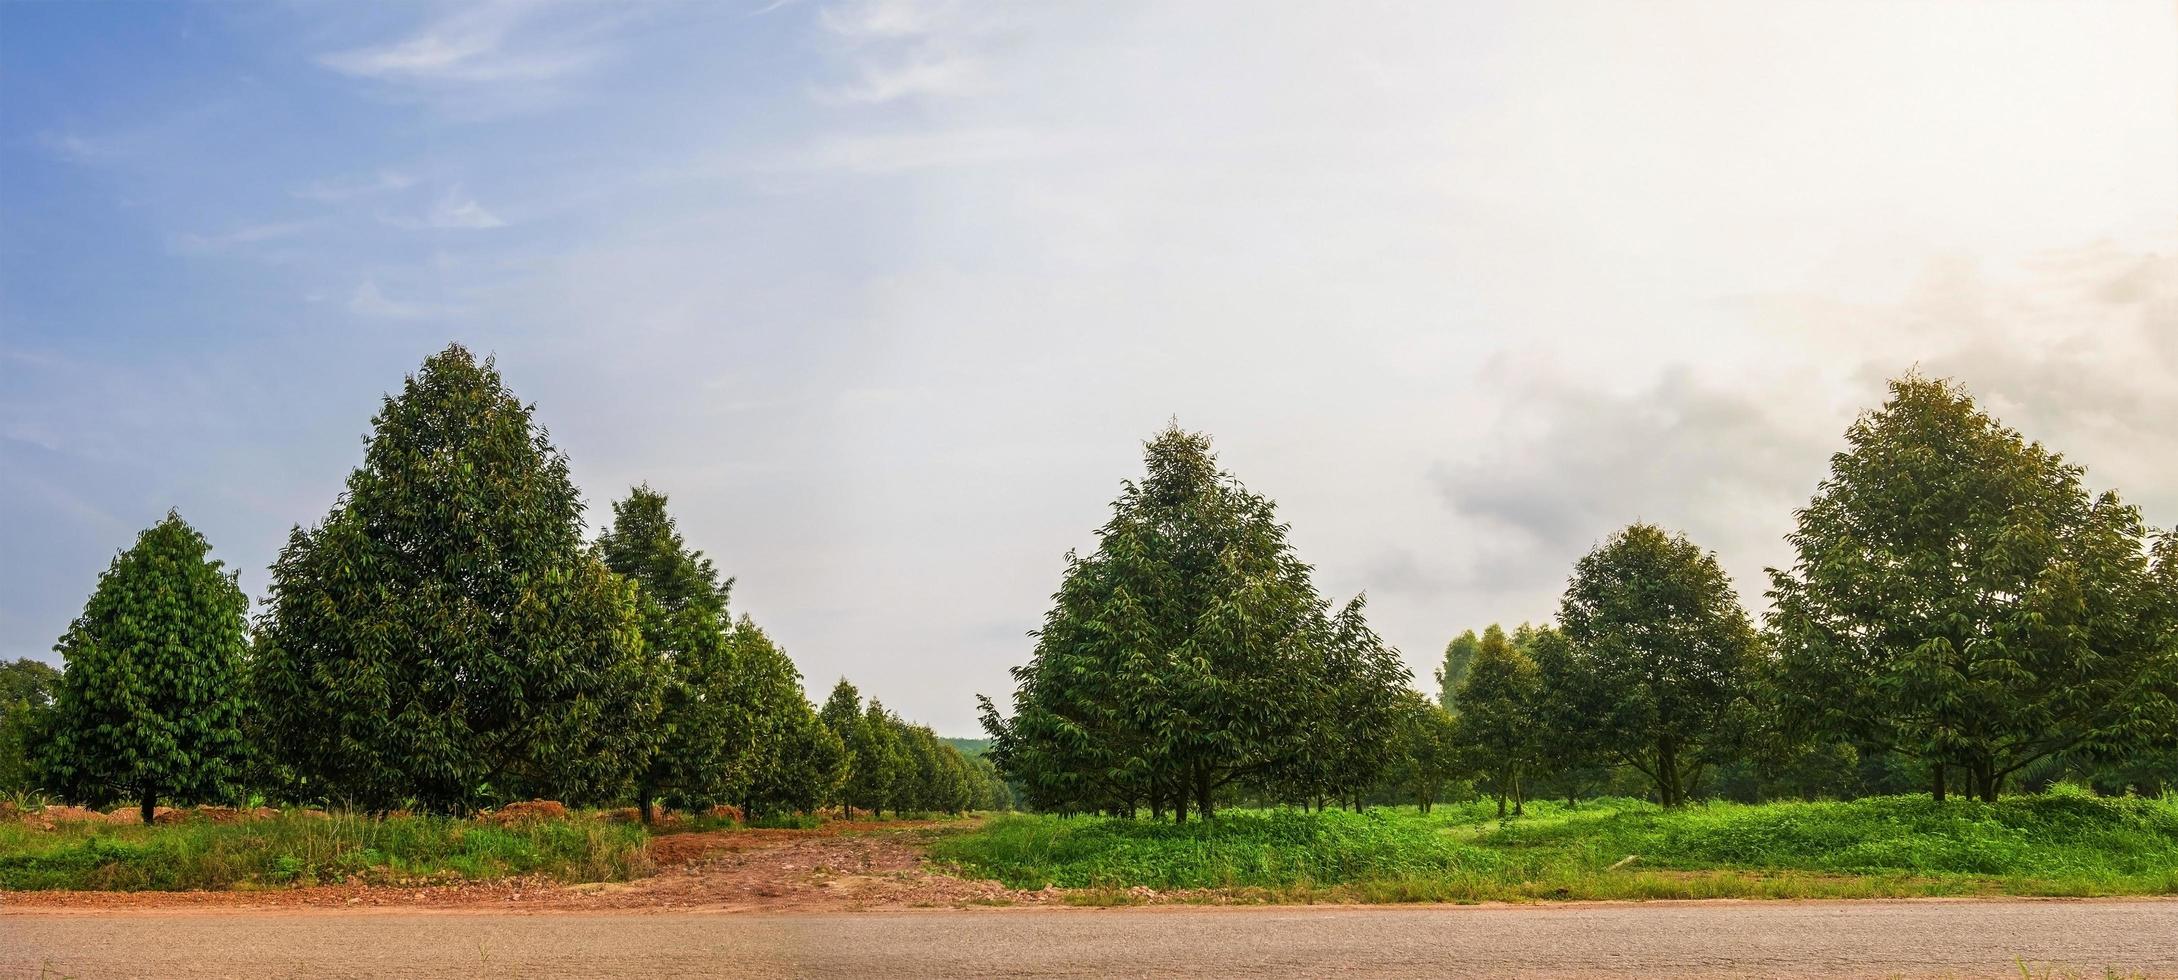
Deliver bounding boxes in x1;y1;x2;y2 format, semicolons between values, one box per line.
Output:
0;899;2178;980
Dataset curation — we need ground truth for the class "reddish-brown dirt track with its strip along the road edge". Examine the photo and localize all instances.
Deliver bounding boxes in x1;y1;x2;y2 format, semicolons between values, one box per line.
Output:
0;821;1056;915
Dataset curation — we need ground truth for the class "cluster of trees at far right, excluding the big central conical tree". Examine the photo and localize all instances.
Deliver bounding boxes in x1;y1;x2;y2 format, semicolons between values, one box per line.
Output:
1437;377;2178;808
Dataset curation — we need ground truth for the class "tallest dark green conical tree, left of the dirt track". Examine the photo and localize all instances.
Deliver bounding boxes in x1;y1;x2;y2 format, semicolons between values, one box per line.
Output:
257;346;662;810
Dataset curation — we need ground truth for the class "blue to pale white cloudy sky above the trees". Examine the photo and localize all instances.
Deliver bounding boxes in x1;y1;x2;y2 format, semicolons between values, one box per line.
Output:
0;0;2178;736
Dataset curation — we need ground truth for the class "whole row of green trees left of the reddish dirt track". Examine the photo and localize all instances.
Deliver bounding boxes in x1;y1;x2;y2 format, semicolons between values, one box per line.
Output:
0;346;1008;821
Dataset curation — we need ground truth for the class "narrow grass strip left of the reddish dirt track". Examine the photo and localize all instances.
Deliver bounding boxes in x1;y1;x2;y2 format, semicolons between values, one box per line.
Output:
0;812;651;891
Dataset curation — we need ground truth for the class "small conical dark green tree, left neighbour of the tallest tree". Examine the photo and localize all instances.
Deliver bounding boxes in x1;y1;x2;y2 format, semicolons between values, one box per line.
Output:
37;512;248;823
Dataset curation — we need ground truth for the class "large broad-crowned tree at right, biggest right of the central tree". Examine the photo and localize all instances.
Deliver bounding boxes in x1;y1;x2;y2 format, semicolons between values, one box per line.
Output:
1771;377;2178;799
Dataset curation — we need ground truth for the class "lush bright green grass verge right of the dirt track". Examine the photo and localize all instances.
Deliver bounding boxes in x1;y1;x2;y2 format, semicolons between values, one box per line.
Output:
932;793;2178;904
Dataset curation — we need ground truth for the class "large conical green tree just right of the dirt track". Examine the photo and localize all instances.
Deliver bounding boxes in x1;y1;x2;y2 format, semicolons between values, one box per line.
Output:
980;427;1405;819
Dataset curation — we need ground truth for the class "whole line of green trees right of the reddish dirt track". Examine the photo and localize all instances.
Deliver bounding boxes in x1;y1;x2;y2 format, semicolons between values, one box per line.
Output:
984;375;2178;819
